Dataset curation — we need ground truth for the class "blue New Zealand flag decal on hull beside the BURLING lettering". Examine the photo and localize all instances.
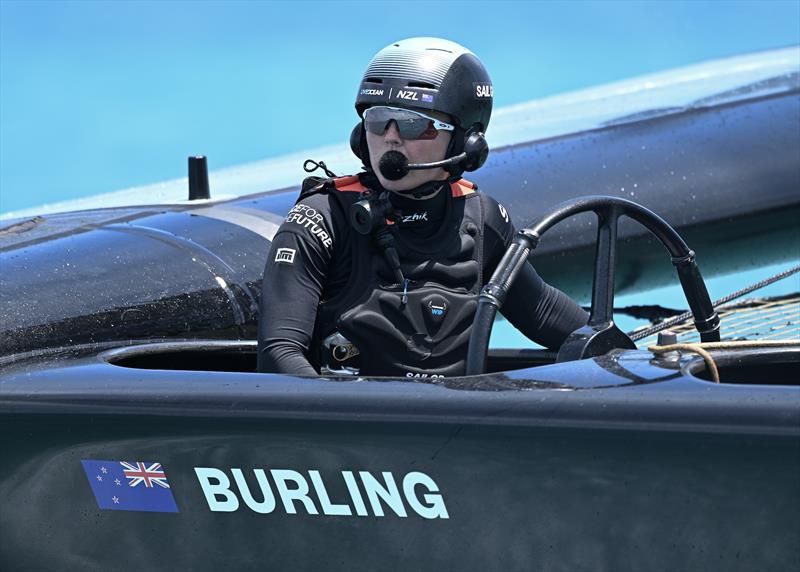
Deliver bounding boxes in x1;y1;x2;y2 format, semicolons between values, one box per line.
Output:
81;461;179;512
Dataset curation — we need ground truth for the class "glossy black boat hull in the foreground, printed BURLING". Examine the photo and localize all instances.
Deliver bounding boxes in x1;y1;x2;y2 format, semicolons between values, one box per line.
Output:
0;344;800;571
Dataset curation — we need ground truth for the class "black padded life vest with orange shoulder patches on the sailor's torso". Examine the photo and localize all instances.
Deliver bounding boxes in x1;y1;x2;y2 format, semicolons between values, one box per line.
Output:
309;176;484;377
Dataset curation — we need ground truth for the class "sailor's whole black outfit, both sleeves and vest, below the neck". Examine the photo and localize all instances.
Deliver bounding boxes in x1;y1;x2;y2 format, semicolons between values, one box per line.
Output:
258;173;588;377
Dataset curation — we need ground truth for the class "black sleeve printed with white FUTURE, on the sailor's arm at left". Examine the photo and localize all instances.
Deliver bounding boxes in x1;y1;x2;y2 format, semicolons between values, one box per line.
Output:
258;195;333;375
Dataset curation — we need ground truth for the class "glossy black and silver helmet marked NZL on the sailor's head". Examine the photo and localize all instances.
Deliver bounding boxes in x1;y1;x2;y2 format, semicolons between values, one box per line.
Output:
356;38;493;132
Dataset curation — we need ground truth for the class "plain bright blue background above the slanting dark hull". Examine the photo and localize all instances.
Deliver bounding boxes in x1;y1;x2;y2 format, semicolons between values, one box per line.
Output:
0;0;800;212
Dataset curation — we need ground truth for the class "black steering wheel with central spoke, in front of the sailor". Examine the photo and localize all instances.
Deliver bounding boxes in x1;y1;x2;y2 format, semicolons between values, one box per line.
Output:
467;196;719;375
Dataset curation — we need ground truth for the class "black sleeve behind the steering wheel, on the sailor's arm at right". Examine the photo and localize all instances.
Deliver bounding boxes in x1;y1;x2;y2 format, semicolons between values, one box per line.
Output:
484;197;589;349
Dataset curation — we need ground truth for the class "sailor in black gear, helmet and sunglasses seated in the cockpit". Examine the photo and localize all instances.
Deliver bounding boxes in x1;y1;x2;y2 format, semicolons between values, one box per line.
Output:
258;38;587;377
